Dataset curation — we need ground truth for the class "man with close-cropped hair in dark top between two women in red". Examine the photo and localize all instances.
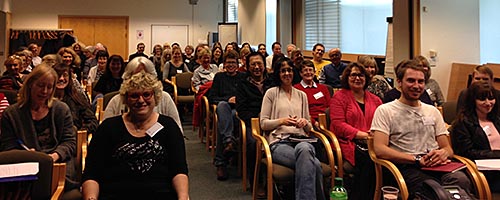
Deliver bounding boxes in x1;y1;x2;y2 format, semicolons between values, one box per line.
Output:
319;48;347;88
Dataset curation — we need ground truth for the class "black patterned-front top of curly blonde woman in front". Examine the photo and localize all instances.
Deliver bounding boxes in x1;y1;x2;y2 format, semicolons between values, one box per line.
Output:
83;115;188;199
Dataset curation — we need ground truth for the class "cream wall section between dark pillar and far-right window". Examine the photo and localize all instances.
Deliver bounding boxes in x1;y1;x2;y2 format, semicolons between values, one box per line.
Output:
420;0;480;98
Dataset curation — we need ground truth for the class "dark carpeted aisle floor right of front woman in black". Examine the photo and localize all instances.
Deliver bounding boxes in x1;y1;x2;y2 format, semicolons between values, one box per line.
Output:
183;120;252;200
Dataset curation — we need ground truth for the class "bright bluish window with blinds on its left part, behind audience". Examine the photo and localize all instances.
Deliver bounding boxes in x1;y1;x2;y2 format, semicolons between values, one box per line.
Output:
304;0;392;55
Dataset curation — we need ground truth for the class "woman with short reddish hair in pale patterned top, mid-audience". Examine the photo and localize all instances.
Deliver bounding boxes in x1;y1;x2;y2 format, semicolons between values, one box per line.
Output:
191;47;219;90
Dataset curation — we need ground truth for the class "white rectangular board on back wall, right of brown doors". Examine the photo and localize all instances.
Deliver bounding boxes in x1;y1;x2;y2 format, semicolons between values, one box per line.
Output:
151;24;189;48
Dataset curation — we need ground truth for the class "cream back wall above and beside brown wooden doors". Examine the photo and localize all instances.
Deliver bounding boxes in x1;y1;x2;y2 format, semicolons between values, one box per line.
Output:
11;0;223;53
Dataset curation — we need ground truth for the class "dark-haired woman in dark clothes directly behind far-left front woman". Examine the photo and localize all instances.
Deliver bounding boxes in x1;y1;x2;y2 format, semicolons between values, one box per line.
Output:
53;63;99;133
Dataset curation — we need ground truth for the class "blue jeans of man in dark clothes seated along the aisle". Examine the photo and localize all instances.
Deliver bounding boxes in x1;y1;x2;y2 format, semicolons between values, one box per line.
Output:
214;101;238;167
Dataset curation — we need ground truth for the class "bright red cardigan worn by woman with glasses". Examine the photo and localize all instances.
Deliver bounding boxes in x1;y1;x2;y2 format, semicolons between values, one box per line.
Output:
330;89;382;166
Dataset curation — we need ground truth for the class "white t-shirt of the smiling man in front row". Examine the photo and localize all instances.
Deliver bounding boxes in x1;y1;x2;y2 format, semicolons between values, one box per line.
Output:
371;100;448;154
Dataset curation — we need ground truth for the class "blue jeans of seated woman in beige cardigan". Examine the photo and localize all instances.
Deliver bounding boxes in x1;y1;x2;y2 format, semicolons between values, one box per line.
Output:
271;142;325;200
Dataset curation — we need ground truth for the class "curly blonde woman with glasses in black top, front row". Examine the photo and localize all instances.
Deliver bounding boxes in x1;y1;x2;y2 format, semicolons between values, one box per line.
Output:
82;71;188;200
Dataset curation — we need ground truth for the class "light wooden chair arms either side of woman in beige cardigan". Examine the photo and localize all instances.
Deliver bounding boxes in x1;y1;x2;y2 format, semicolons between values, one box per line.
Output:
252;118;335;200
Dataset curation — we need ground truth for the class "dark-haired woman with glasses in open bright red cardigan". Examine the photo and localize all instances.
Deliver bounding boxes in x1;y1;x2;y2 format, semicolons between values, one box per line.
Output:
330;63;382;199
